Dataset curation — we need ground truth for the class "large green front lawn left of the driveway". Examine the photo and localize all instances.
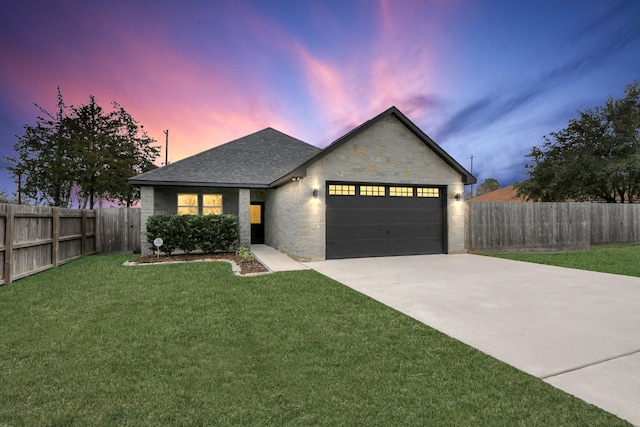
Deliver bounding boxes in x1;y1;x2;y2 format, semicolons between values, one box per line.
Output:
0;256;627;426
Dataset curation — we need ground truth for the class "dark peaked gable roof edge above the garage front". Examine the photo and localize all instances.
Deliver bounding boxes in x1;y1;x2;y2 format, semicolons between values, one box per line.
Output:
274;106;478;185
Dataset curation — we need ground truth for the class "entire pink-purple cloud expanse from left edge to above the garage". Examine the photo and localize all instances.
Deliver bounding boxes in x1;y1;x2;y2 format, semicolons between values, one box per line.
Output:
1;0;460;169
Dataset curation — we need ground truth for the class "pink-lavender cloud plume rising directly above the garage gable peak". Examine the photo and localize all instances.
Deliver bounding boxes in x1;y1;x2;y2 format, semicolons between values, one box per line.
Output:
295;0;458;136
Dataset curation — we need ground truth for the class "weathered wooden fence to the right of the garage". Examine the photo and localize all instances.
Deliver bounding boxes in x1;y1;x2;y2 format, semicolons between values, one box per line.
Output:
465;202;640;251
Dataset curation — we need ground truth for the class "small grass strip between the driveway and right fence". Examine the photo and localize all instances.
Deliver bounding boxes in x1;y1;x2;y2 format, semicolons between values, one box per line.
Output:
482;244;640;277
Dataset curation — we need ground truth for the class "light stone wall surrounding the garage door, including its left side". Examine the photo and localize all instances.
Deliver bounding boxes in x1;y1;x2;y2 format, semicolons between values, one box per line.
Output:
265;117;465;260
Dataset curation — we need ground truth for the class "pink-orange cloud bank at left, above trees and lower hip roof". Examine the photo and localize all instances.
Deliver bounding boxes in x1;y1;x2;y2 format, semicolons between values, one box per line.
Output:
3;3;295;166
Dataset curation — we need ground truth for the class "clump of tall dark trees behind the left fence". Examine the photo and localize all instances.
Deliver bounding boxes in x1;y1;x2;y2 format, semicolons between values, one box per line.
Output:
6;89;159;209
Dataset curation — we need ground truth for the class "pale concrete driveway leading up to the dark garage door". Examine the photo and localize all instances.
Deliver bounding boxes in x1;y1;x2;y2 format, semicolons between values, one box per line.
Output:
305;255;640;425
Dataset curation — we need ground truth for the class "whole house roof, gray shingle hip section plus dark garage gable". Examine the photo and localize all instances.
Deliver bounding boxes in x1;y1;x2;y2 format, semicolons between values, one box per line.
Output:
129;107;477;188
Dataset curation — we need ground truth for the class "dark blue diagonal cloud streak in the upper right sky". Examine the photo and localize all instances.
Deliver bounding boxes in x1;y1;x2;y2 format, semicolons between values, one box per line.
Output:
438;2;640;139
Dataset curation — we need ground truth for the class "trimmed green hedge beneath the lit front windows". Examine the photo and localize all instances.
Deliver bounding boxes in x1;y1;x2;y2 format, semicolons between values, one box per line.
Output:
147;215;238;255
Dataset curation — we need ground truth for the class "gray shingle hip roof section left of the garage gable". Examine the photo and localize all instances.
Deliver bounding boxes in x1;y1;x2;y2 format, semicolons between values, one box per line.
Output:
129;128;321;188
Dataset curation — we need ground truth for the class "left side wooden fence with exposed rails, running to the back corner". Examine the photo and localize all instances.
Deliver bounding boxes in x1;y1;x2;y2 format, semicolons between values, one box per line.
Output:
0;204;97;284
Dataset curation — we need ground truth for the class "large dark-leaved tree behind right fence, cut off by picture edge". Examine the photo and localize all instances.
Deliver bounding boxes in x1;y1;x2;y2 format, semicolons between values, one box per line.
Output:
515;82;640;203
